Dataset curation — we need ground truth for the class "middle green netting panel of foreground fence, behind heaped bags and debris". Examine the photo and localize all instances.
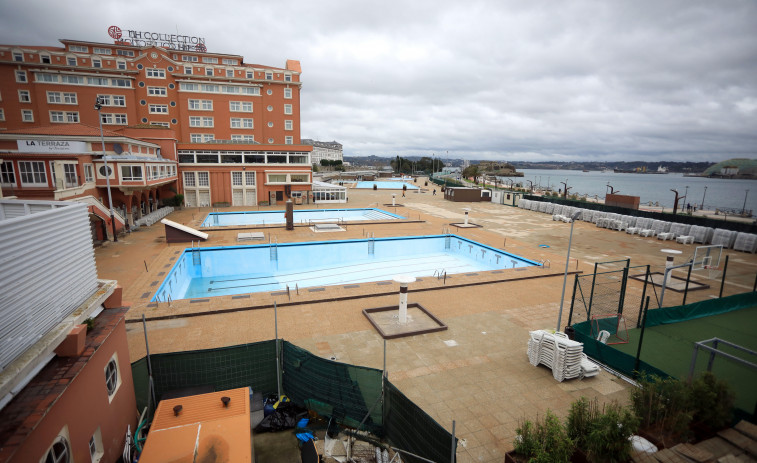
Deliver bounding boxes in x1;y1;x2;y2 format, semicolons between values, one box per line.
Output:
283;342;383;435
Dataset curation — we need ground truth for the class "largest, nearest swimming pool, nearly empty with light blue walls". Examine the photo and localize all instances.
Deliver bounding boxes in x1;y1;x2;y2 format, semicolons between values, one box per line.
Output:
152;235;539;301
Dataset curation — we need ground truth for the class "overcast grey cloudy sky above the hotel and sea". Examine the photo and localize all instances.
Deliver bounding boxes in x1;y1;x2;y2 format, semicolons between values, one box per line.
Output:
0;0;757;162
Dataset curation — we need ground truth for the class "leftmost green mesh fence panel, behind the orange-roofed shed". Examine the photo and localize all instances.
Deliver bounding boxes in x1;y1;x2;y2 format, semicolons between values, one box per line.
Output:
132;340;276;410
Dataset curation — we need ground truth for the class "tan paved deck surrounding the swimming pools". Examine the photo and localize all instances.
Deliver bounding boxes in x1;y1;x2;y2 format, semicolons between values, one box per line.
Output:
96;183;757;462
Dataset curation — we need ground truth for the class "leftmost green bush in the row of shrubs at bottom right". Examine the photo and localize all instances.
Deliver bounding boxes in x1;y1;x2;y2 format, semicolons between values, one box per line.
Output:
514;410;574;463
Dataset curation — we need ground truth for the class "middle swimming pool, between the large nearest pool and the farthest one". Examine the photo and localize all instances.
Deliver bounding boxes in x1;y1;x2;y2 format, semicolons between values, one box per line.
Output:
200;208;404;227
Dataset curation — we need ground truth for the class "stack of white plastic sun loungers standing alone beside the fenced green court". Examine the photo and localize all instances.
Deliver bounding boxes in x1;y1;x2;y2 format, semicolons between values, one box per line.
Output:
527;330;599;382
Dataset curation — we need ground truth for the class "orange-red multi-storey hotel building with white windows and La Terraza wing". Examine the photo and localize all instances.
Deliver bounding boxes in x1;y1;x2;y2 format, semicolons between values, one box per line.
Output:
0;30;312;239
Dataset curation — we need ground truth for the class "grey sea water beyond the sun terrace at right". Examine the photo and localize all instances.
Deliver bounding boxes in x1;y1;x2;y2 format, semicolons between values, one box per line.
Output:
504;169;757;216
